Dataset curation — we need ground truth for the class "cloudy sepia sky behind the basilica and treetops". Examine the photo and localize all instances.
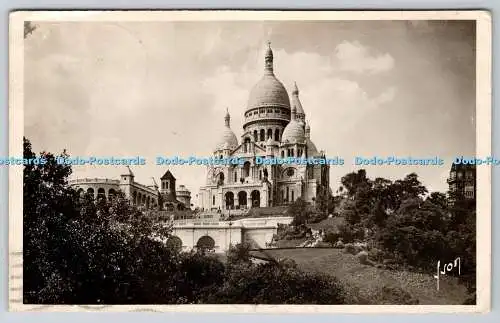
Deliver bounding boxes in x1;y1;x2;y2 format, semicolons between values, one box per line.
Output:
24;20;476;200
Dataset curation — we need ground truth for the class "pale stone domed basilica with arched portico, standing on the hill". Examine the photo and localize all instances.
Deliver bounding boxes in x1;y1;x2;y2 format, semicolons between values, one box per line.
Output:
198;46;329;214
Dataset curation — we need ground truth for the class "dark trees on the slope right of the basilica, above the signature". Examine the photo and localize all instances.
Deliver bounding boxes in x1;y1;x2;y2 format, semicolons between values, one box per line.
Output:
332;170;476;302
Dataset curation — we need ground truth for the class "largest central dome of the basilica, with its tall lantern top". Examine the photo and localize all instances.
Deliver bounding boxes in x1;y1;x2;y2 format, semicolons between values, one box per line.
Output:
247;44;290;111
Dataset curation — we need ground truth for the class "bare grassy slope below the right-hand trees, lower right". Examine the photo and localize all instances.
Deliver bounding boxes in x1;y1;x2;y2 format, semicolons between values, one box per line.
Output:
254;248;467;305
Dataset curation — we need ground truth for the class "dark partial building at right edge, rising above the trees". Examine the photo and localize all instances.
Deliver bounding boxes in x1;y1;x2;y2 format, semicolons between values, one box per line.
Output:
447;163;476;204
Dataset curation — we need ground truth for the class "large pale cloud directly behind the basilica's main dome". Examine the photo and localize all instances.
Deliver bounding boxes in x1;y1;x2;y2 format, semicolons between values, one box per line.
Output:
202;48;396;162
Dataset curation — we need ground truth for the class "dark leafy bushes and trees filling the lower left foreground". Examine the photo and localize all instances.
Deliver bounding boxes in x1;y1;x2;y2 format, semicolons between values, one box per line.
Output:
23;140;343;304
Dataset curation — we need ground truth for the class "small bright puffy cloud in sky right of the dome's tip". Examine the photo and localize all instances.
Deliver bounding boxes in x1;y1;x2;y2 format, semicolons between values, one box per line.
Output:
335;41;394;74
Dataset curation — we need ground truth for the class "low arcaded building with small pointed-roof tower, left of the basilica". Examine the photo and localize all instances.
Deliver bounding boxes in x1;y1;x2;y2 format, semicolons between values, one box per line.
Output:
69;167;191;210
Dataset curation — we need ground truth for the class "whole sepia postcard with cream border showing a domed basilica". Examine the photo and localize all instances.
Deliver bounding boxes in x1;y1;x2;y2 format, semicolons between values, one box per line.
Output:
7;11;492;313
